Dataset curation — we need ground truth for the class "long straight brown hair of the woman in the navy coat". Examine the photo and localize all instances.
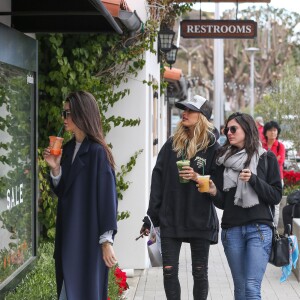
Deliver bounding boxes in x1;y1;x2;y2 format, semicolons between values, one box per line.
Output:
66;91;115;169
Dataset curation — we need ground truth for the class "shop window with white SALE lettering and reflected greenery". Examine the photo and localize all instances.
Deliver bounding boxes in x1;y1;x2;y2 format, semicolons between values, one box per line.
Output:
0;23;36;290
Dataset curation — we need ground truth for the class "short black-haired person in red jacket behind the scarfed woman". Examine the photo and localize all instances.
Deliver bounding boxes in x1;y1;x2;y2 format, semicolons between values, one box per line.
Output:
263;121;285;226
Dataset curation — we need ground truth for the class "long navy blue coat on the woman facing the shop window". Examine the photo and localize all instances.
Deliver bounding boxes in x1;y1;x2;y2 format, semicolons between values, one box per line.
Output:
54;138;117;300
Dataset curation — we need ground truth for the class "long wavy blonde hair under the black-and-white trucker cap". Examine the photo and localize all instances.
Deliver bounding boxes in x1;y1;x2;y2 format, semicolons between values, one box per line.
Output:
172;113;216;159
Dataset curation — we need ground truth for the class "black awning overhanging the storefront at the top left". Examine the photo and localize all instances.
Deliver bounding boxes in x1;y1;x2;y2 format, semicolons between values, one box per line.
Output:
0;0;133;34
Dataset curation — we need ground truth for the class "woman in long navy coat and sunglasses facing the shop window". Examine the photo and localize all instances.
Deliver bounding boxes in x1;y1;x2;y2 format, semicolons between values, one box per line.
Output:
44;91;117;300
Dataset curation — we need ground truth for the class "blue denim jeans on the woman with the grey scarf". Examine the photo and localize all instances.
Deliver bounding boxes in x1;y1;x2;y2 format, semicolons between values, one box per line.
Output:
221;224;272;300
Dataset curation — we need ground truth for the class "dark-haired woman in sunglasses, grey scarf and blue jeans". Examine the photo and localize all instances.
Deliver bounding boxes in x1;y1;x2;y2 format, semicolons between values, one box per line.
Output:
205;113;282;300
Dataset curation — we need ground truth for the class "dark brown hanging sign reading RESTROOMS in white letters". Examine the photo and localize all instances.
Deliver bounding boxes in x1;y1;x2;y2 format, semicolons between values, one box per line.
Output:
180;20;257;39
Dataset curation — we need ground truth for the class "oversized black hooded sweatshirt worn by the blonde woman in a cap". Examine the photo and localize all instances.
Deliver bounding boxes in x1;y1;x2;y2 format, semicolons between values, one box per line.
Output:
147;138;219;243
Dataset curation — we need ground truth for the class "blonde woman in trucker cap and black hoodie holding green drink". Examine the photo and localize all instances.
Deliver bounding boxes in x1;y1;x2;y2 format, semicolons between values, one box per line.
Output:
140;96;219;300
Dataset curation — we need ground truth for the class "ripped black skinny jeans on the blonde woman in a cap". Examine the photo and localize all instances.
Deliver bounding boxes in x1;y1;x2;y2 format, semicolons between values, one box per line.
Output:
161;237;210;300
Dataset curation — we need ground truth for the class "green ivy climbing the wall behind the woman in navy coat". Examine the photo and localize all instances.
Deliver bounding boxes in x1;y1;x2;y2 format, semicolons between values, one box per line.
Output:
37;1;191;239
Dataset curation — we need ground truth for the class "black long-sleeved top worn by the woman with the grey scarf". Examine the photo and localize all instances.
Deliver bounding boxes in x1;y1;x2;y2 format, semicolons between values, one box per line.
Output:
211;151;282;229
